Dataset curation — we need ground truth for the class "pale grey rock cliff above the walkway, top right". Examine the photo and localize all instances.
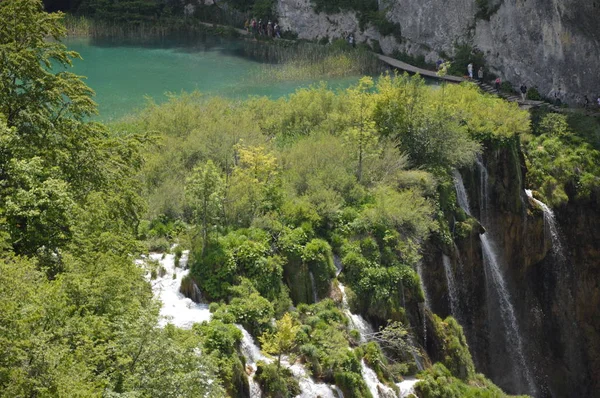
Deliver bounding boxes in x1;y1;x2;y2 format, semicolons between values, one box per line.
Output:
277;0;600;102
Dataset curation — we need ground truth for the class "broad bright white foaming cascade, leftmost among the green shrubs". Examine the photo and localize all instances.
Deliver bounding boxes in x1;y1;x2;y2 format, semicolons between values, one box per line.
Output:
145;251;212;329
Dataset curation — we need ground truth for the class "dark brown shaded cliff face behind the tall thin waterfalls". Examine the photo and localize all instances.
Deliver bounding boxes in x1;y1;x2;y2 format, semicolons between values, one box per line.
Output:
423;143;600;397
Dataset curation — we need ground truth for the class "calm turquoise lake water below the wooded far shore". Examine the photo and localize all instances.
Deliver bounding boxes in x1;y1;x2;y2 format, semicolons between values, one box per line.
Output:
65;37;366;121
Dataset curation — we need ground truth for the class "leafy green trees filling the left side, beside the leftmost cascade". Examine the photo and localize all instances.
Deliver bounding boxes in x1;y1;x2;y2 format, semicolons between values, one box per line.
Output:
0;0;222;397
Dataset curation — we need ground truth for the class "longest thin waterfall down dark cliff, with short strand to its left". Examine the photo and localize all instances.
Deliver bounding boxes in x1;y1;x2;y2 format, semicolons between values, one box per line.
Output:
454;165;537;395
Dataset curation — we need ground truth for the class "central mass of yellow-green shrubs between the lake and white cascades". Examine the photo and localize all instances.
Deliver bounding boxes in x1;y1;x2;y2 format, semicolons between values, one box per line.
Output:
114;66;529;396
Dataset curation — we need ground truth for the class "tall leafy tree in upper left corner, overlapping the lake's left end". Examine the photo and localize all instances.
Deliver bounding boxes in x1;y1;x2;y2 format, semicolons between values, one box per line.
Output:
0;0;111;254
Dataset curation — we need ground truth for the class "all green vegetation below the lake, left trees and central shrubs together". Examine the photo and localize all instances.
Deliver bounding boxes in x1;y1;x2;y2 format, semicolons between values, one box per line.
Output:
0;0;600;397
